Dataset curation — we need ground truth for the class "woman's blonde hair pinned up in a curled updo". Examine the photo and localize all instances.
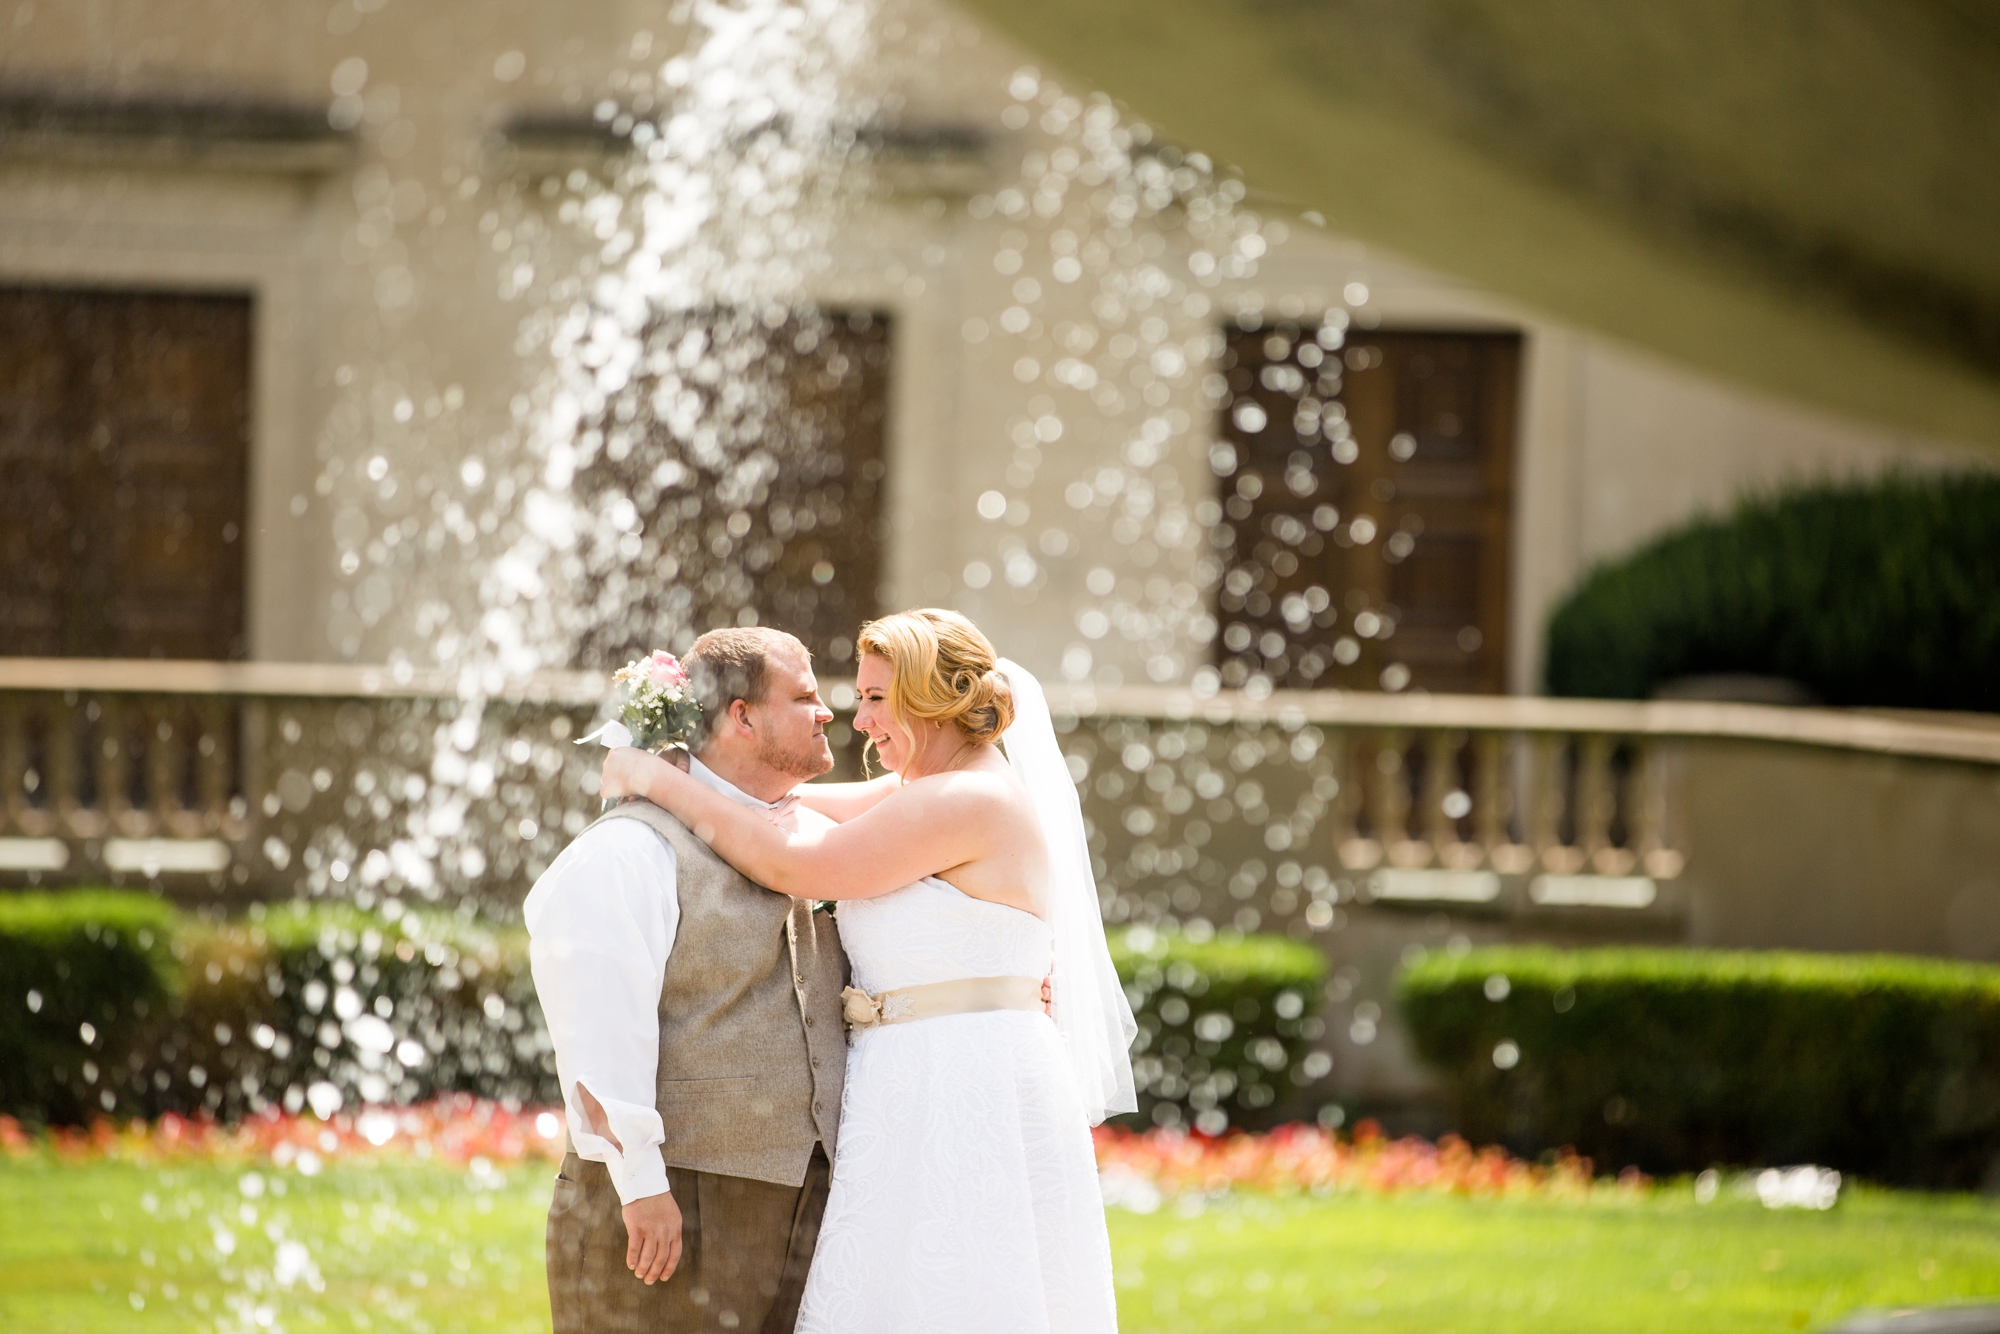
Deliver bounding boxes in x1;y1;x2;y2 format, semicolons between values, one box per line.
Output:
854;606;1014;742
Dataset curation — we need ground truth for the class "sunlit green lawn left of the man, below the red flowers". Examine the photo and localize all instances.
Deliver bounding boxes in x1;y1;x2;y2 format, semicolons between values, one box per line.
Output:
0;1160;554;1334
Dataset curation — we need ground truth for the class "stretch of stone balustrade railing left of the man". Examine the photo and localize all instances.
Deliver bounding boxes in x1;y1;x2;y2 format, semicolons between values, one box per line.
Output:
0;658;604;892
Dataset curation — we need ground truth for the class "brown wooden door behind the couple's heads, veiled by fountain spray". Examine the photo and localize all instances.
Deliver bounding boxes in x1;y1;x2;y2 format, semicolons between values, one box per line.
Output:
584;312;890;676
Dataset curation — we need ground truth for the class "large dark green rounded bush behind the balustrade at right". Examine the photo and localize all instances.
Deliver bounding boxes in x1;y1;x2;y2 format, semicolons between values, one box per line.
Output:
1548;474;2000;712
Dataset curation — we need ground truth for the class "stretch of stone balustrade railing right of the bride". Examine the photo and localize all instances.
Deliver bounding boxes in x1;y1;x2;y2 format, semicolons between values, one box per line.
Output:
1052;686;2000;924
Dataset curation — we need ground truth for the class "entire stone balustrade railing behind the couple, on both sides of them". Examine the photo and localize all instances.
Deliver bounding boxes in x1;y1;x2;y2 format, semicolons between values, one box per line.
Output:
0;658;2000;902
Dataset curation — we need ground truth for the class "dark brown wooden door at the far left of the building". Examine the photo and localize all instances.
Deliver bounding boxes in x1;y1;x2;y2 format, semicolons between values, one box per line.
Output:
0;288;250;660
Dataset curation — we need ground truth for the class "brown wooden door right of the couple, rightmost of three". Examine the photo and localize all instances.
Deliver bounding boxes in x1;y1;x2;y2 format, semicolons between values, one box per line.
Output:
1216;326;1520;692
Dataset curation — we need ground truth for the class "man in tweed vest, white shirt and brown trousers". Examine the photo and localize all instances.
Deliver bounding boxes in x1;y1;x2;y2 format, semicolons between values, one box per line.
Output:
524;628;848;1334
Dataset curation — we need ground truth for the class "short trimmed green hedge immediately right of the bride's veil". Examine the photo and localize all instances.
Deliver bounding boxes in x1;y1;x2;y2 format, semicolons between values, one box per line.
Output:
1110;926;1326;1130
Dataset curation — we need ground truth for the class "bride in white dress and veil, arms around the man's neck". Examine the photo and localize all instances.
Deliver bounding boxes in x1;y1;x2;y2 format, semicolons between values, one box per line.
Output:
604;610;1134;1334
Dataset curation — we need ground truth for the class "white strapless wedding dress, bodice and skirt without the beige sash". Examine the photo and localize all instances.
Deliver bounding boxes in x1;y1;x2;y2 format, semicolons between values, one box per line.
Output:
798;880;1118;1334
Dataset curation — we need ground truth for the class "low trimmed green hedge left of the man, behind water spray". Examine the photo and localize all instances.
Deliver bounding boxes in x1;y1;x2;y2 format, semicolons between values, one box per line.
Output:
0;890;556;1122
